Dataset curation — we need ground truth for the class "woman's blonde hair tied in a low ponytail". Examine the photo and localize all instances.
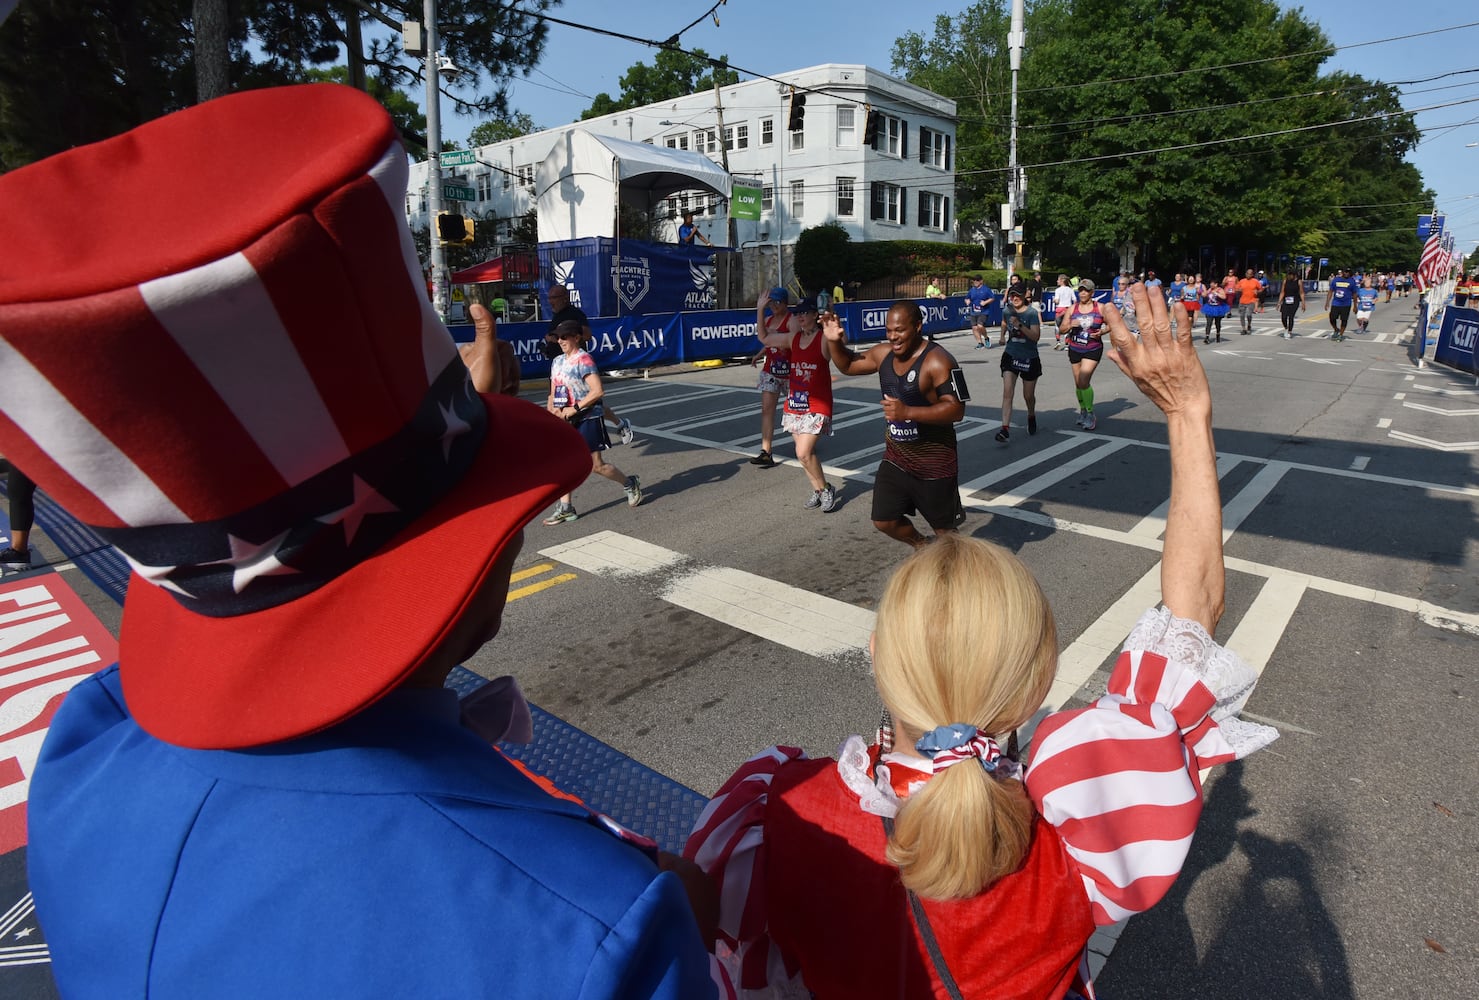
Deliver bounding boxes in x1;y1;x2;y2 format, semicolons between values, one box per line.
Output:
873;534;1057;899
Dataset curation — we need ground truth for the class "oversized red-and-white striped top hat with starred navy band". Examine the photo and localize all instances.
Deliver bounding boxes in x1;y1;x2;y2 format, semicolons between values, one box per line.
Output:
0;84;590;747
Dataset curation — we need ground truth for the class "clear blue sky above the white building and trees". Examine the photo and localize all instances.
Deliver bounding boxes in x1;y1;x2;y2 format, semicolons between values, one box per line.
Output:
444;0;1479;257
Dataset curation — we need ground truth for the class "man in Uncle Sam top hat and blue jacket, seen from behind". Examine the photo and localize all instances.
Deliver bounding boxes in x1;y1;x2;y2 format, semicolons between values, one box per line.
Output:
0;84;727;1000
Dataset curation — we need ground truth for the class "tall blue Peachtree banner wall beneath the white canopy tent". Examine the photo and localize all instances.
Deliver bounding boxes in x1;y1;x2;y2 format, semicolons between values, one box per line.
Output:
540;237;732;318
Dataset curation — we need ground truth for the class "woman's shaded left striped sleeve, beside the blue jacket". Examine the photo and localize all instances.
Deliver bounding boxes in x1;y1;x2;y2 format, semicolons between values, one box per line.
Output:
683;747;806;997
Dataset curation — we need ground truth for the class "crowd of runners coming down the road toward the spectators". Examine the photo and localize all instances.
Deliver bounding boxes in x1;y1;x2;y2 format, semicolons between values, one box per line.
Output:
544;261;1411;546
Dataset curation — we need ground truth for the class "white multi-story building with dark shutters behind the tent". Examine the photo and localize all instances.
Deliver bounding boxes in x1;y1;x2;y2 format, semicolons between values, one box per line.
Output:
407;64;955;247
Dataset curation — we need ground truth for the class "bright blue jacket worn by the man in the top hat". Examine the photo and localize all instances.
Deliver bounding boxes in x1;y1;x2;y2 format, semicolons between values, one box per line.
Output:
28;667;714;1000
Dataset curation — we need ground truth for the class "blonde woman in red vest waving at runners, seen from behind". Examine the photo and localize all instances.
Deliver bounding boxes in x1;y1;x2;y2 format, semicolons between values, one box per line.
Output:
685;286;1278;1000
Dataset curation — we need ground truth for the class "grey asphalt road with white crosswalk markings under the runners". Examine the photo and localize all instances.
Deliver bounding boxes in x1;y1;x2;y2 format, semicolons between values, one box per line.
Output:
0;296;1479;1000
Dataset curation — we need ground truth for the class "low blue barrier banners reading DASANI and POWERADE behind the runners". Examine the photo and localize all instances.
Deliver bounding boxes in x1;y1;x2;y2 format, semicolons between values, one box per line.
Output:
450;296;1001;379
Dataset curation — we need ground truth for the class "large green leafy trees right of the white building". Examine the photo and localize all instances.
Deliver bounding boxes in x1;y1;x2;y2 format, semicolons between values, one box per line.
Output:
893;0;1423;271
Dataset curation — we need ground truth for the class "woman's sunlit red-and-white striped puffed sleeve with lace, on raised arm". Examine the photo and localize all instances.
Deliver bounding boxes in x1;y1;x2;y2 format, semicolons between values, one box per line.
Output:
1026;609;1278;925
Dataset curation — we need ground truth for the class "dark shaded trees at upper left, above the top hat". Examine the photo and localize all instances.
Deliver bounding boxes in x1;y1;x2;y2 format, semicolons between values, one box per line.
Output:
0;0;558;169
